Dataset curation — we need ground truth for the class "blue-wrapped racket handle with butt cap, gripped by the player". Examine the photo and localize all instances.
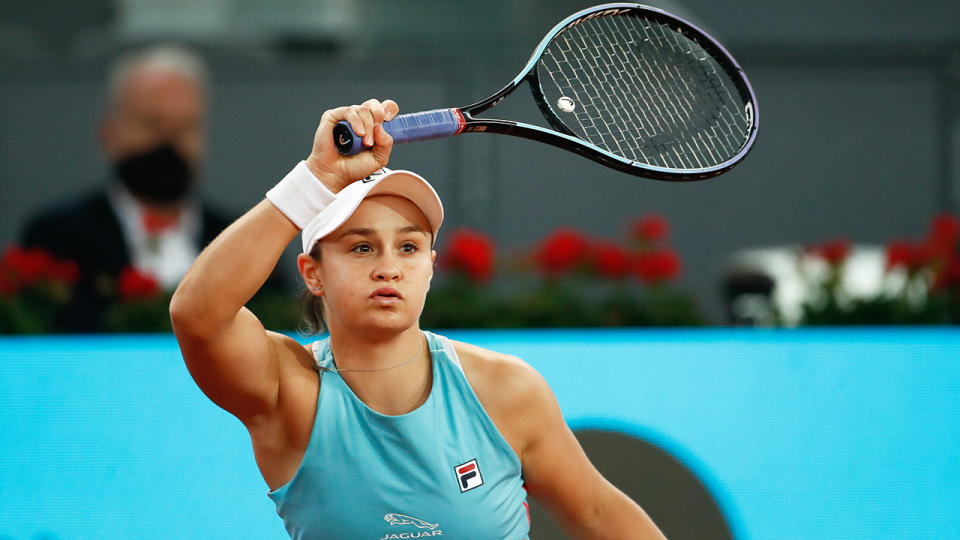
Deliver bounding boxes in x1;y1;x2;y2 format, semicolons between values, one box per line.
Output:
333;109;465;156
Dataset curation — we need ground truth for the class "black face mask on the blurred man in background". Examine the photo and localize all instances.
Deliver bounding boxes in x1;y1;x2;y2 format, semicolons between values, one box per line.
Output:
113;143;193;203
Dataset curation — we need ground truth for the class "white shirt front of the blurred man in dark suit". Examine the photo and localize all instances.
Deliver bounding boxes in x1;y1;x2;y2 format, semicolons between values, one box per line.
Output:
107;184;201;290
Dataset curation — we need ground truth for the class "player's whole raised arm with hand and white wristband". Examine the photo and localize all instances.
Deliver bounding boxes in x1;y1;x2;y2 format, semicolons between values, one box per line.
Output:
170;100;397;422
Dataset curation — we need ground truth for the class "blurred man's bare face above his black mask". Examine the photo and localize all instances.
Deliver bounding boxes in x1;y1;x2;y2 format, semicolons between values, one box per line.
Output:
101;68;206;167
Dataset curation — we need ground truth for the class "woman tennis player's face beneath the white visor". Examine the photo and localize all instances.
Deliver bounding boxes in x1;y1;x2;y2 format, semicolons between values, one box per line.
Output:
316;195;436;332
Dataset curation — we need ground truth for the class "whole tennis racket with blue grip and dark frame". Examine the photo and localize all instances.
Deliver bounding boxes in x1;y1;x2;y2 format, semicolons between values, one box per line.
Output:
333;3;758;180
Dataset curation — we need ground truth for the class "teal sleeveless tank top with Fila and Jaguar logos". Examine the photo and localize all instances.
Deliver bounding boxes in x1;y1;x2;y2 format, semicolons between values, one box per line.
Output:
268;332;530;540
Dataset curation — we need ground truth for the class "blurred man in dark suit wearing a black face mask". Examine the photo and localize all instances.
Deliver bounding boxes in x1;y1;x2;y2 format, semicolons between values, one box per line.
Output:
21;45;229;331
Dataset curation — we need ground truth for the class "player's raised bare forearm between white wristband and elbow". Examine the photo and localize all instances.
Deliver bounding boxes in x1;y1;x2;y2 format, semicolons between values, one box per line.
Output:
170;200;299;332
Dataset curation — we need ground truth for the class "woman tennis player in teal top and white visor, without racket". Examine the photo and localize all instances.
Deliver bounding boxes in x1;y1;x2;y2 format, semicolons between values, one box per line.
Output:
170;100;663;540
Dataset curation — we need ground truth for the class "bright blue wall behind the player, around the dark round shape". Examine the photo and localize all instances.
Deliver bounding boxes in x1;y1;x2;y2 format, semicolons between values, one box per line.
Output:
0;329;960;539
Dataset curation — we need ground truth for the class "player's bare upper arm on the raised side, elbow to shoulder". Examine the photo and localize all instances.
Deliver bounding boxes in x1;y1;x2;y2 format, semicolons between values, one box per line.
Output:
174;308;292;421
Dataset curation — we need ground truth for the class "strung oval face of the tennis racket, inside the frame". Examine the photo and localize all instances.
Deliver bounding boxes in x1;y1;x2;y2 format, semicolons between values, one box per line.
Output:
541;11;748;169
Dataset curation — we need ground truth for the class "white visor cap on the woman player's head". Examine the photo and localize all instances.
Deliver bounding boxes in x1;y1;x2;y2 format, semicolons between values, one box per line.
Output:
302;167;443;254
